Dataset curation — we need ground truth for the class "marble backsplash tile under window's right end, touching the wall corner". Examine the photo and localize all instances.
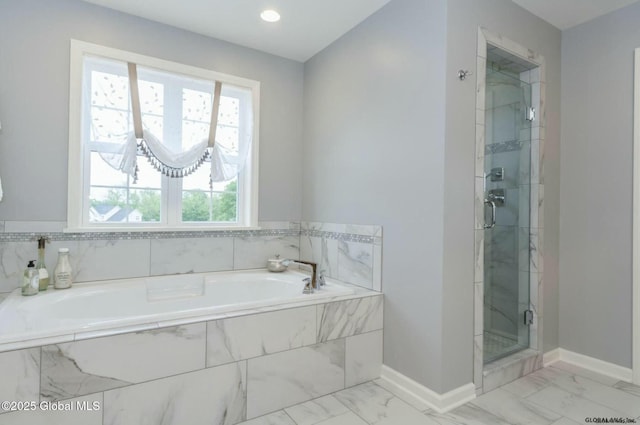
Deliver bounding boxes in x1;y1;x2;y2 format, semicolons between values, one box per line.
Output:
233;236;300;270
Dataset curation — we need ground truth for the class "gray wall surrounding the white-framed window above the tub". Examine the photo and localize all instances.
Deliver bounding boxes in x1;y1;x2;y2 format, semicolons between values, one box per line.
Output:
0;0;303;221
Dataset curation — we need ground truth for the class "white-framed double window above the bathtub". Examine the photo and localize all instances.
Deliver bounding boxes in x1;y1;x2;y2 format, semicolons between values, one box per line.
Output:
68;41;259;231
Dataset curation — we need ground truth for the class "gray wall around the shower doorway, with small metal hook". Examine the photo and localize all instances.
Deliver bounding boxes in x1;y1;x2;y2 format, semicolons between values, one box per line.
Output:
443;0;561;390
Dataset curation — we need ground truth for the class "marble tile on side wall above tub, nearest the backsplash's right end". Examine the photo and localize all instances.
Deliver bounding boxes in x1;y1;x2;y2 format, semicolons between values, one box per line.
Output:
338;241;373;289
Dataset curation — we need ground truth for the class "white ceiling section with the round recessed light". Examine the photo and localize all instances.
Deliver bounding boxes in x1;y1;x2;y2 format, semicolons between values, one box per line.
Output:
84;0;390;62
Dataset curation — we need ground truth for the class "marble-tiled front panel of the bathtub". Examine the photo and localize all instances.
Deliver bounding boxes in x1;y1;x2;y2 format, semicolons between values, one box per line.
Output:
0;292;383;425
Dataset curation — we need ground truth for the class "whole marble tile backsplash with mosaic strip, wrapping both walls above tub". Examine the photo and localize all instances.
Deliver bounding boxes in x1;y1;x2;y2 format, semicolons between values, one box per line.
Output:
0;221;382;294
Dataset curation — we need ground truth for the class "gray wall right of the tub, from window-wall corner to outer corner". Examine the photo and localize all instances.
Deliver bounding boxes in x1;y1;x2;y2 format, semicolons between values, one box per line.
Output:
303;0;448;391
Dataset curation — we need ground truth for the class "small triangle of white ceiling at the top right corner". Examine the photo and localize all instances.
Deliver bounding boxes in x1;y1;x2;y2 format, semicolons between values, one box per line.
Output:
513;0;639;30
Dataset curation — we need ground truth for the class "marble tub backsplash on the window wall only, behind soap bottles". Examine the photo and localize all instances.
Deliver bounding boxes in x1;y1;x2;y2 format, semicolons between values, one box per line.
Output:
0;222;300;292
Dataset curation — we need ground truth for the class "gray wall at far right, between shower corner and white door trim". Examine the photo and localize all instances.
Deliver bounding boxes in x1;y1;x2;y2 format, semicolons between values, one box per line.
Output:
560;4;640;367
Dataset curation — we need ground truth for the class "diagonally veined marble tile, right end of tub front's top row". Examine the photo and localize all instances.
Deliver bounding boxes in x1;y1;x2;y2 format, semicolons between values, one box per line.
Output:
317;295;383;342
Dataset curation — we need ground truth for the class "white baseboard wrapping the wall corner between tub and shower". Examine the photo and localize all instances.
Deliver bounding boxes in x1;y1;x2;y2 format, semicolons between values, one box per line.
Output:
380;365;476;413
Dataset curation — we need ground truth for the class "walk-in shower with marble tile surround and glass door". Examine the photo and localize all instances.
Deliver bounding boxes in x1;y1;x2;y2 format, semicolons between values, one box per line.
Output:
473;28;546;393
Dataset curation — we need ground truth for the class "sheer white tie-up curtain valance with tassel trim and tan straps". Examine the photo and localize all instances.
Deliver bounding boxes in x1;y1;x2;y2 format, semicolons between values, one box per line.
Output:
95;58;253;182
